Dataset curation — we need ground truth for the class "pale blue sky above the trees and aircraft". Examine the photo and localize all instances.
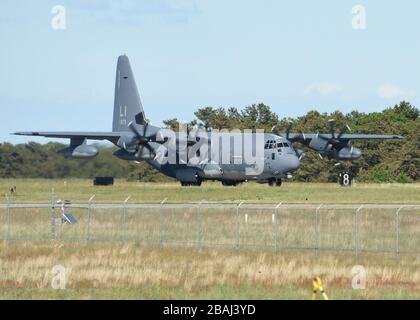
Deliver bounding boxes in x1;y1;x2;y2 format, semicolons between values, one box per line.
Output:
0;0;420;143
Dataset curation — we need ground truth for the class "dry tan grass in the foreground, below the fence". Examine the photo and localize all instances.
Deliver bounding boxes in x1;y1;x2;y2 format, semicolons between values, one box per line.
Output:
0;242;420;299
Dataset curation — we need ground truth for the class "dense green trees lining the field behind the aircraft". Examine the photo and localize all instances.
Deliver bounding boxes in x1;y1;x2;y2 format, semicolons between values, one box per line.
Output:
0;101;420;182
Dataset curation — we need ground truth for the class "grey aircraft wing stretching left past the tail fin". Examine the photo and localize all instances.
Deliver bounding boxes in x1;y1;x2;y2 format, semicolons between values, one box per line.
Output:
14;131;124;143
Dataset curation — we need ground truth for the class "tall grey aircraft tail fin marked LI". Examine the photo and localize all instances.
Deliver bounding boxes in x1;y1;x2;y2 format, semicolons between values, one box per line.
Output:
112;55;146;132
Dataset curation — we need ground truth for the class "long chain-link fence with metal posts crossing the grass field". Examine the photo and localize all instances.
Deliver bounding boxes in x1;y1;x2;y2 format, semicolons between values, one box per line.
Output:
0;198;420;255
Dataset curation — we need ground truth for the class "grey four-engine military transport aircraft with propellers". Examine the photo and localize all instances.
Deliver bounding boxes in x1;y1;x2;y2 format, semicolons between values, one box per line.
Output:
15;55;402;186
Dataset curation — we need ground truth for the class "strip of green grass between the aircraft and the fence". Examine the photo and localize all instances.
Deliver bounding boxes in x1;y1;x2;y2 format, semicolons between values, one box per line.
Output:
0;179;420;204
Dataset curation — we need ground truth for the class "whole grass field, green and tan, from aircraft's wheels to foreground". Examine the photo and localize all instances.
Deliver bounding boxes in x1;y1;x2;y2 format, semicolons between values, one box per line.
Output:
0;180;420;299
